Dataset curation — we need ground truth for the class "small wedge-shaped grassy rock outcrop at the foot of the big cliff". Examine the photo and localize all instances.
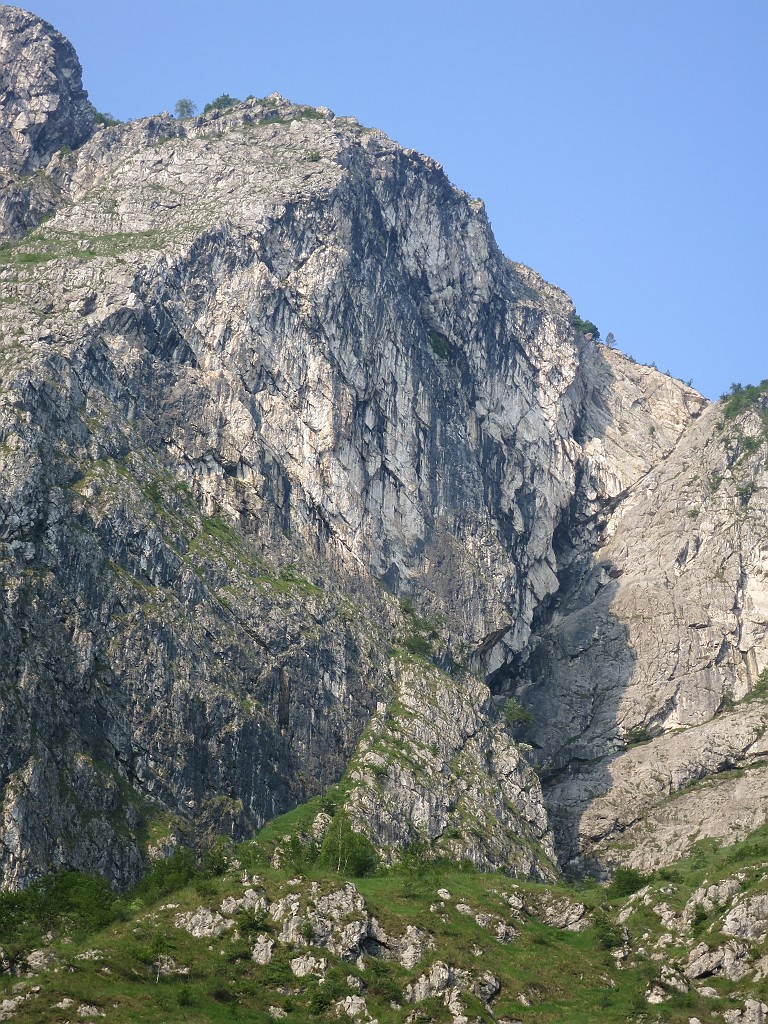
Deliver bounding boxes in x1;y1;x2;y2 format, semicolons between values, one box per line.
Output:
345;658;555;879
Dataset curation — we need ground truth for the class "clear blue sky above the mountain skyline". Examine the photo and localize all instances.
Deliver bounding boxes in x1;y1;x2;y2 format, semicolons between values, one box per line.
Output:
20;0;768;397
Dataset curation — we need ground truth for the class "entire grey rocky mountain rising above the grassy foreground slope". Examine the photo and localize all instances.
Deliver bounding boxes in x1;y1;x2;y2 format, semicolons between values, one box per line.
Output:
0;0;768;921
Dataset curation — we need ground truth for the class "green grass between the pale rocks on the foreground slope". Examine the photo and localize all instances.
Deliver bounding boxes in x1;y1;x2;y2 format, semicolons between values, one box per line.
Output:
0;800;768;1024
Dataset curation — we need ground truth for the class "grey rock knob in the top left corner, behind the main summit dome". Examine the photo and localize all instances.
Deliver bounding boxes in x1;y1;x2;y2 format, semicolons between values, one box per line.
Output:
0;6;94;174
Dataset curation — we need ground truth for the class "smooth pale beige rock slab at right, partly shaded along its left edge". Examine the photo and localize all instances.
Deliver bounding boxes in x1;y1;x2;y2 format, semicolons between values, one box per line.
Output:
522;407;768;867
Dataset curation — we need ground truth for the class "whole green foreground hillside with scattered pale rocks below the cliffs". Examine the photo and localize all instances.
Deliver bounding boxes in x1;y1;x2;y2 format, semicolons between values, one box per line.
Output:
0;797;768;1024
